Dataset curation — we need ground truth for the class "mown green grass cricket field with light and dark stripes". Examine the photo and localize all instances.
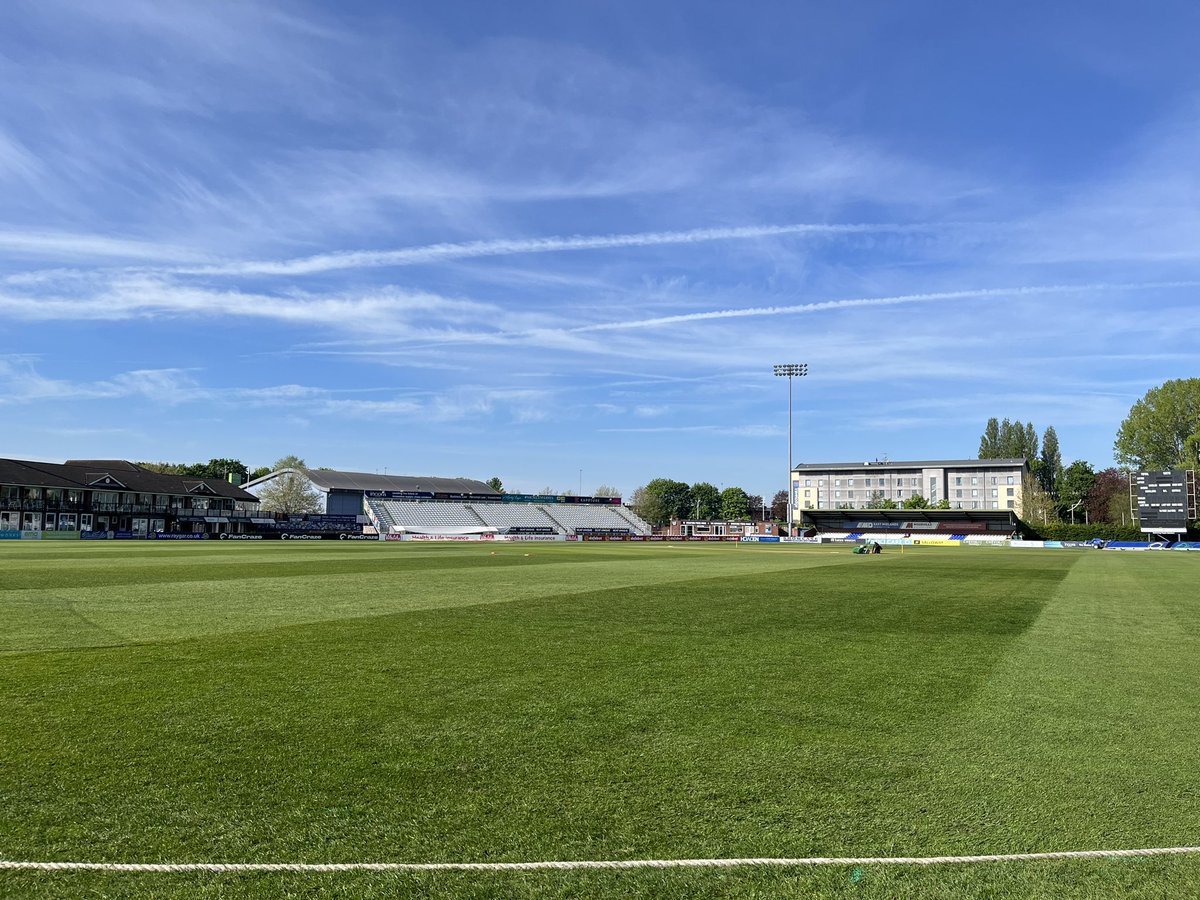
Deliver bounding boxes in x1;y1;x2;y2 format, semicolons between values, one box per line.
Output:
0;544;1200;898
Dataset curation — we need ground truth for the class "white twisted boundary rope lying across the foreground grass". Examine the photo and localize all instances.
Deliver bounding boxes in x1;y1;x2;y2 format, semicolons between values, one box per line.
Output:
0;847;1200;872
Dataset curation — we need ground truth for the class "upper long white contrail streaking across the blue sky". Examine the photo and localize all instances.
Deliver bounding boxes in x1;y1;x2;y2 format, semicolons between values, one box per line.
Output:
172;223;945;275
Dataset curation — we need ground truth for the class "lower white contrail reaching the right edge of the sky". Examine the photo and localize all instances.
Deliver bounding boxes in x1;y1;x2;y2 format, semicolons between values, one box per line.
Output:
566;281;1200;332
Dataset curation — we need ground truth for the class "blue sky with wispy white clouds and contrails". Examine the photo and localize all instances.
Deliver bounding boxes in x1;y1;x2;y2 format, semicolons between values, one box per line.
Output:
0;0;1200;496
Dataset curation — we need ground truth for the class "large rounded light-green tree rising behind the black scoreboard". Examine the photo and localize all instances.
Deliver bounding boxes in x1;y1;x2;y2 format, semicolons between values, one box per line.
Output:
1112;378;1200;470
